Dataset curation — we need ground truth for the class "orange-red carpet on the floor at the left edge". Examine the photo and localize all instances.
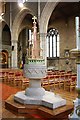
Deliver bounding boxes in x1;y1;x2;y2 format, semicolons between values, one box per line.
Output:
0;83;20;100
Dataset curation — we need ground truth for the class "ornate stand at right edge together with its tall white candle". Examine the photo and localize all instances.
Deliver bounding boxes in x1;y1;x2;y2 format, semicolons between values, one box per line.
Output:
69;17;80;120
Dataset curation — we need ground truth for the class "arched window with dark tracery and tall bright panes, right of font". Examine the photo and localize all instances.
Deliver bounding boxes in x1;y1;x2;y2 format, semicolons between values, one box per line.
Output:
47;28;60;58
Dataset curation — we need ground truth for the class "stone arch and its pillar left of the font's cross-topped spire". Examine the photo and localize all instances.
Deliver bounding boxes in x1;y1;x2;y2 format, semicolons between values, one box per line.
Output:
11;7;33;68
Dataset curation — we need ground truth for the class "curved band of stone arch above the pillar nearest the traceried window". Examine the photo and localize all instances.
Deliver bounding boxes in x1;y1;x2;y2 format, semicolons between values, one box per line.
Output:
40;0;60;33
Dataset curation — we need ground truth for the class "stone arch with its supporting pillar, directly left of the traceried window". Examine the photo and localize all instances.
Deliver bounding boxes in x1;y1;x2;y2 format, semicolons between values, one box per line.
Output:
40;0;60;60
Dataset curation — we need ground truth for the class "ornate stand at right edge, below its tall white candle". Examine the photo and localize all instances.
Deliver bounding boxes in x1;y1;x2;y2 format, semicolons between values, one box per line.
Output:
69;49;80;120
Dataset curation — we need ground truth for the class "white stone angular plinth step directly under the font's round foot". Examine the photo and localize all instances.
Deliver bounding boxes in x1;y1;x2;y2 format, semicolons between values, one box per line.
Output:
14;91;66;109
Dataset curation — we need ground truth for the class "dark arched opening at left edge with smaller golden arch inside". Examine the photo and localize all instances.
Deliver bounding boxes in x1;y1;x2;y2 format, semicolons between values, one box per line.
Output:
0;19;11;68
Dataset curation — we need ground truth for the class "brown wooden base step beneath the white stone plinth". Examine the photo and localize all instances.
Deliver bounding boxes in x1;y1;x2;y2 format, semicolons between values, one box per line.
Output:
5;95;73;120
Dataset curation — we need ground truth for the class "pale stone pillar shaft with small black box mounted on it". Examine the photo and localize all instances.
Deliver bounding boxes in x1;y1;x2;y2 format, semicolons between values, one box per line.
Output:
11;40;18;68
